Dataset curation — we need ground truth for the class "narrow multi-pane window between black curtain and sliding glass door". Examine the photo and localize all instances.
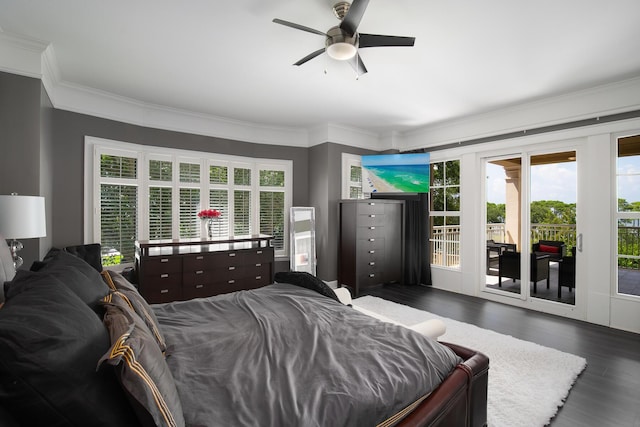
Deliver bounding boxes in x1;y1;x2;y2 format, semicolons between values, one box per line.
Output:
429;160;460;268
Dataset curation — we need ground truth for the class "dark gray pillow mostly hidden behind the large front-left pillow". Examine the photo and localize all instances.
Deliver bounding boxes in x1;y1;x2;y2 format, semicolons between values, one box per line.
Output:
11;250;109;317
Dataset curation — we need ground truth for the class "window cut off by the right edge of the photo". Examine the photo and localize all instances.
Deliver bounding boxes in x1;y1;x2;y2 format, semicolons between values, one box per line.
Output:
616;135;640;296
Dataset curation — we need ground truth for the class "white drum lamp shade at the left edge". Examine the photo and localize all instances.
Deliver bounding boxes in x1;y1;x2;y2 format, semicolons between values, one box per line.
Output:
0;194;47;239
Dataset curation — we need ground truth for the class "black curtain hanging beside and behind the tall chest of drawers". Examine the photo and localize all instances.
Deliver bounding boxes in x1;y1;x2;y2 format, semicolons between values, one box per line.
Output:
371;193;431;285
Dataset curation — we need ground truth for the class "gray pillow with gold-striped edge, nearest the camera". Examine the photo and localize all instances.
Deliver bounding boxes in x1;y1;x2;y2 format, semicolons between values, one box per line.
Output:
100;295;185;427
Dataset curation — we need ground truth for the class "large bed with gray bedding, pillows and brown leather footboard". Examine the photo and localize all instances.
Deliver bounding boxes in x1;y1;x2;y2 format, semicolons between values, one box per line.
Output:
0;242;488;427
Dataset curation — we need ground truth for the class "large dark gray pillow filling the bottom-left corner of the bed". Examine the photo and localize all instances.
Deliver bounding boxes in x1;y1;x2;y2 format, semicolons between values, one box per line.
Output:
0;275;137;427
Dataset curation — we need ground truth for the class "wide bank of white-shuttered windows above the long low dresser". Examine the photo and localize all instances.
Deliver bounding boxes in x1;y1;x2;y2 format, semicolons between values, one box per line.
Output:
85;137;292;266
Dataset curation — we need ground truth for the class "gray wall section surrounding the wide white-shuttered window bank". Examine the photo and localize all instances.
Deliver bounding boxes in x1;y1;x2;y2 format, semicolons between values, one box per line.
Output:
53;110;309;247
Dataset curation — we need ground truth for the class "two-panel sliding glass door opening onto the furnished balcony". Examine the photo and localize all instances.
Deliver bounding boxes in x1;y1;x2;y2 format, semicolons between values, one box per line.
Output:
483;151;579;305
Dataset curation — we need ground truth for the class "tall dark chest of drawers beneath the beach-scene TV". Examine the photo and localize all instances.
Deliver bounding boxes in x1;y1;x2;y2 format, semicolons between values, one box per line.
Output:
338;199;404;297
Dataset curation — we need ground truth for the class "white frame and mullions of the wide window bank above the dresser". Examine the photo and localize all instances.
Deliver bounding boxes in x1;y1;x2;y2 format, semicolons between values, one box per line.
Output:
84;136;293;267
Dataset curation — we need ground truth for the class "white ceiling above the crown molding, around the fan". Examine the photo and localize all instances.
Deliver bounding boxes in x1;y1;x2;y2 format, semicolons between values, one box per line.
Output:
0;0;640;144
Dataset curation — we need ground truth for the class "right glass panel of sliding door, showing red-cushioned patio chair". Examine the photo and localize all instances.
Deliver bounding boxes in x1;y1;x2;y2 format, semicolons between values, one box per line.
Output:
523;151;579;305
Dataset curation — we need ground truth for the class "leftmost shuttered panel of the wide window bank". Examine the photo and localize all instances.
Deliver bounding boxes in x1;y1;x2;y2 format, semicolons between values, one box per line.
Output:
100;154;138;266
